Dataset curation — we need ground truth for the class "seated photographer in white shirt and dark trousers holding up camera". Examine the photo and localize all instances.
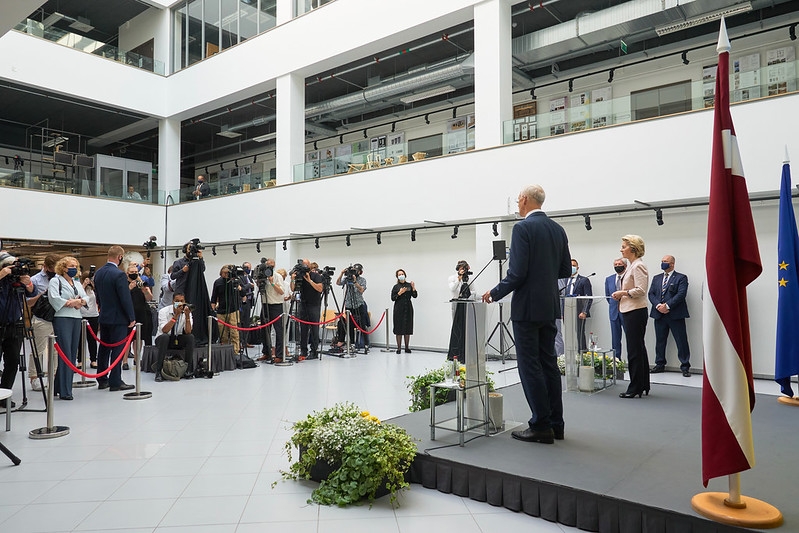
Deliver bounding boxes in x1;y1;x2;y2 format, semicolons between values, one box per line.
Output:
155;293;194;382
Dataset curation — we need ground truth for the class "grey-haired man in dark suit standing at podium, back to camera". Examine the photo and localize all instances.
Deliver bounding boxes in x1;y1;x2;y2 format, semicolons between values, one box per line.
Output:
483;185;571;444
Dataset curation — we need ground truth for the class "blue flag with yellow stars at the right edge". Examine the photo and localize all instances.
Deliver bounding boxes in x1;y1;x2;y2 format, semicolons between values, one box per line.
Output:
774;159;799;397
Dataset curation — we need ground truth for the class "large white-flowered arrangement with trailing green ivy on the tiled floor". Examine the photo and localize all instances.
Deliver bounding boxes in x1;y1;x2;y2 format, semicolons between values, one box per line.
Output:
281;402;416;507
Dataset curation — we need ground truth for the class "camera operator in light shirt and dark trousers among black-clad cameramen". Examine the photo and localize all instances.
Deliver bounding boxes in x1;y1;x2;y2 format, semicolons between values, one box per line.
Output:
255;259;286;363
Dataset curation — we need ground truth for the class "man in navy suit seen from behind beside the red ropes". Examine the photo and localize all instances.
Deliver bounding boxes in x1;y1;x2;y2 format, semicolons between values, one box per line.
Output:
94;246;136;391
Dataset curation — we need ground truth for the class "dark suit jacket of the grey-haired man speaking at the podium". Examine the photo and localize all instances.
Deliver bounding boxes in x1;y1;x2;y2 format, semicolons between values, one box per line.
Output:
491;211;571;321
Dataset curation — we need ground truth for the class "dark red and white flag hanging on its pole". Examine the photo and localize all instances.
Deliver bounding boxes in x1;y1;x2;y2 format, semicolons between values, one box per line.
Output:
702;19;763;487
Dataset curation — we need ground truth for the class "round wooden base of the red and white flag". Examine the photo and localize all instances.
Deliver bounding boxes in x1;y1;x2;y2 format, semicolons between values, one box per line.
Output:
691;492;782;529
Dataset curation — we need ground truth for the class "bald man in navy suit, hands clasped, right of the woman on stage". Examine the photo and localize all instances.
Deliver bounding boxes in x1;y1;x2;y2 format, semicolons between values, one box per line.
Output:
649;255;691;378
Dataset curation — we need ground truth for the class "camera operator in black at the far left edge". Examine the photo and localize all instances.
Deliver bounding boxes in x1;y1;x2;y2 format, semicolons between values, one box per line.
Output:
0;250;38;407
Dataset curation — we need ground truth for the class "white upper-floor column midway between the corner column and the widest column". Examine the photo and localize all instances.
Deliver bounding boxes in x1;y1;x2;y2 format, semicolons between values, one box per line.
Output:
275;74;305;185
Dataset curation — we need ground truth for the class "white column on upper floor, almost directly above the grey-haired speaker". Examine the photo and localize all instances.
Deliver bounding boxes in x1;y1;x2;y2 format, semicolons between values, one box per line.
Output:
474;0;513;149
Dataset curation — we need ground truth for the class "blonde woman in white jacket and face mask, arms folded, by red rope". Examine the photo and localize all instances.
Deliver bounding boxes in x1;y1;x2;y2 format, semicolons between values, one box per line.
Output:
47;256;88;400
